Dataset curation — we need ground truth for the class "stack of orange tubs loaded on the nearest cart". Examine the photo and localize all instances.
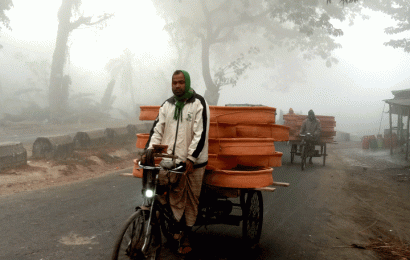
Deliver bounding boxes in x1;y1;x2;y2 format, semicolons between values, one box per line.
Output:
134;106;289;188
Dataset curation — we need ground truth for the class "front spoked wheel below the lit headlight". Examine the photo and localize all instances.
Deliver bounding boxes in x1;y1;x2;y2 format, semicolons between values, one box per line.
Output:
111;210;161;260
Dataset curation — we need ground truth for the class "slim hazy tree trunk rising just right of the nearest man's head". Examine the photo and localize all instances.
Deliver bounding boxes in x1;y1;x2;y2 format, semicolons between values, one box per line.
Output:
202;39;219;106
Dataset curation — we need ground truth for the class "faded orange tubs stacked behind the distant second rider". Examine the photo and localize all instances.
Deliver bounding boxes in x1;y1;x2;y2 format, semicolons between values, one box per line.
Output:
283;114;336;143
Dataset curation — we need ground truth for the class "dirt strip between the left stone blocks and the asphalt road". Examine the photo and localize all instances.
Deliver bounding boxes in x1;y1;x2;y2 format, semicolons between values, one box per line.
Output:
0;144;141;196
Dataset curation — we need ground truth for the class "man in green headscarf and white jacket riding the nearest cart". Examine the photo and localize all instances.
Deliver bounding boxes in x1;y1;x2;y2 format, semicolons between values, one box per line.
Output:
146;70;210;254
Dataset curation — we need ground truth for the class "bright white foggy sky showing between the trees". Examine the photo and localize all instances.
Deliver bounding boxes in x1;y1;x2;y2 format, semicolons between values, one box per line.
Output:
0;0;410;135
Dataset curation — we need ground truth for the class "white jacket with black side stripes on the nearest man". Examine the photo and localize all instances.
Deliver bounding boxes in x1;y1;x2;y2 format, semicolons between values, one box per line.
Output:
146;92;210;168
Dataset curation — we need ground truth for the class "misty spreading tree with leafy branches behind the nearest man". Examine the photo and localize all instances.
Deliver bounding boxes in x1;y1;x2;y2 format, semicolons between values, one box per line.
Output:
153;0;361;105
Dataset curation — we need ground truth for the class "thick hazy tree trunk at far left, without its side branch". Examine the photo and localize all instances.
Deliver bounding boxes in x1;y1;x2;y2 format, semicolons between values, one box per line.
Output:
49;0;73;121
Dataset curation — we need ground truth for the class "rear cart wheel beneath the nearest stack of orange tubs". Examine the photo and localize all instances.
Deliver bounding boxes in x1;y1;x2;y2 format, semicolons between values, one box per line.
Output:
242;190;263;248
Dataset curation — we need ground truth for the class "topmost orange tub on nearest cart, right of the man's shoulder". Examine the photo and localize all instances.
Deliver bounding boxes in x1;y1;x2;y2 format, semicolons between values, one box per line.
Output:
209;106;276;124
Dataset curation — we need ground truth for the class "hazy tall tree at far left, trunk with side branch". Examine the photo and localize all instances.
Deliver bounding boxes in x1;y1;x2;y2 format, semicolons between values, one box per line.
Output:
49;0;113;120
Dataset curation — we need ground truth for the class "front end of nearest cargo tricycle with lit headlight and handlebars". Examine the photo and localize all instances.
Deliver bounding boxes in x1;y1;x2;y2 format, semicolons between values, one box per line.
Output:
111;147;185;260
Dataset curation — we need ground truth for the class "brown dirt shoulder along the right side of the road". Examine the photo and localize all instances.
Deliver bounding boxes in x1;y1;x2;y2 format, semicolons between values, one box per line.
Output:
321;143;410;260
